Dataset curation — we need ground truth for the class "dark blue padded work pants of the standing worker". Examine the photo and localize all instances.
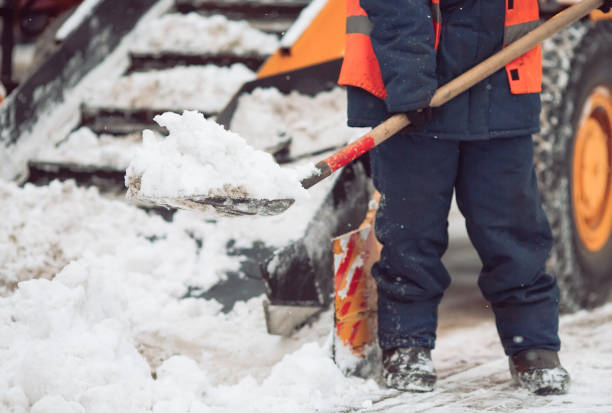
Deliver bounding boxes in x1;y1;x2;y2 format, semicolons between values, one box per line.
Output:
371;134;560;355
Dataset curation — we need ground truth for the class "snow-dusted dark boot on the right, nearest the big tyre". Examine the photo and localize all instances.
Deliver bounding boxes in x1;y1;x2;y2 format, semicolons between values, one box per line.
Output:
508;349;570;395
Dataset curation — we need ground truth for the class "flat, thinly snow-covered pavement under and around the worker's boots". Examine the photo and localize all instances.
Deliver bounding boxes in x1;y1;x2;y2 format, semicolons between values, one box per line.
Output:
354;304;612;413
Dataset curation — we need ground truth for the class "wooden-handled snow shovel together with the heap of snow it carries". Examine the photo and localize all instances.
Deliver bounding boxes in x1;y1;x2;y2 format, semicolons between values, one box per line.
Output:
126;0;601;219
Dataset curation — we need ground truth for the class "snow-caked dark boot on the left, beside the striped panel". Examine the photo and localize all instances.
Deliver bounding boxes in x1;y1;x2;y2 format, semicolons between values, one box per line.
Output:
383;347;436;392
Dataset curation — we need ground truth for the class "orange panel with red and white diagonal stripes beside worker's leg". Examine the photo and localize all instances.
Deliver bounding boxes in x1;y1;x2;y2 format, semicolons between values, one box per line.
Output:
333;192;381;377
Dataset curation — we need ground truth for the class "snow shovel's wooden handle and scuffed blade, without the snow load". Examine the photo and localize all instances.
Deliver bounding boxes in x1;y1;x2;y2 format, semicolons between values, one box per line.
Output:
141;0;603;216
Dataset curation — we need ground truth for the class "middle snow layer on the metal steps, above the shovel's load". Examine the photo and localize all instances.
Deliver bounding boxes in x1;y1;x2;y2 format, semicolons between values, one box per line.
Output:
86;63;255;113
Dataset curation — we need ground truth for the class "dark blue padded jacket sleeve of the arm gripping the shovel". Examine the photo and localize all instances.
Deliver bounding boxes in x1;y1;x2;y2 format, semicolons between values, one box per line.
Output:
360;0;438;113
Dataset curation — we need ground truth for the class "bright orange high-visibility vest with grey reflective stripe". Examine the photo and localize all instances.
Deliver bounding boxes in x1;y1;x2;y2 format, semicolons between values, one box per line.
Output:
338;0;542;99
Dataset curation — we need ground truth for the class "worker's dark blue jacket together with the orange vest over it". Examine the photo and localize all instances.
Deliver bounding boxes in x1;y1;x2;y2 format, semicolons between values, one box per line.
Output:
341;0;542;140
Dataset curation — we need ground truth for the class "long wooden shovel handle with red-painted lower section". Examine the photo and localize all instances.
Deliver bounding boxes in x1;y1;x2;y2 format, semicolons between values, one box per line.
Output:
302;0;603;189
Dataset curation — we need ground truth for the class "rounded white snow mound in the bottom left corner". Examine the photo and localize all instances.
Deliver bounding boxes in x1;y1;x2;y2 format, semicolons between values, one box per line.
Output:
0;260;224;413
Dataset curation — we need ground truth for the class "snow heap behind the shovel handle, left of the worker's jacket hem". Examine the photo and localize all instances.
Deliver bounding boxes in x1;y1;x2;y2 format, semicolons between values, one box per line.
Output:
231;88;365;157
